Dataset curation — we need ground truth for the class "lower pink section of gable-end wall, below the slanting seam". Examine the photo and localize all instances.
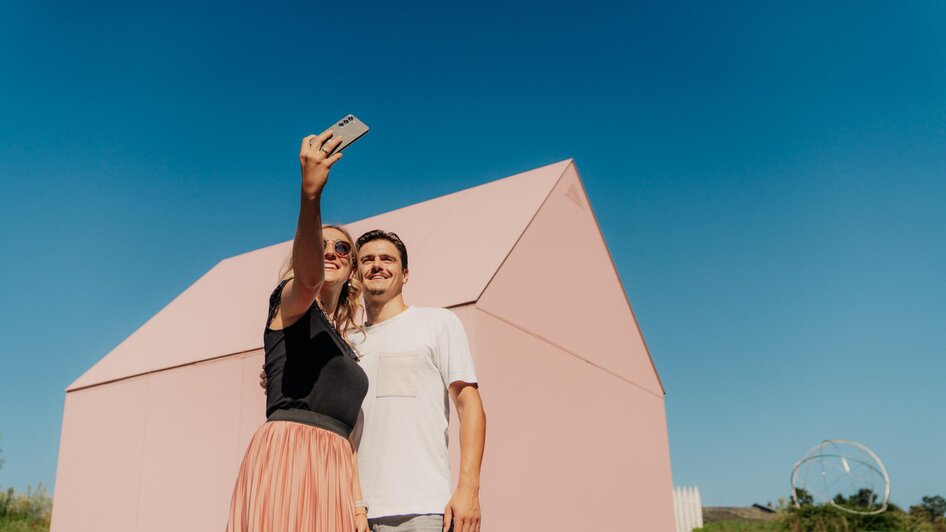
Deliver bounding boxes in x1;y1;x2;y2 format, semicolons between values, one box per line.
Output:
475;312;674;531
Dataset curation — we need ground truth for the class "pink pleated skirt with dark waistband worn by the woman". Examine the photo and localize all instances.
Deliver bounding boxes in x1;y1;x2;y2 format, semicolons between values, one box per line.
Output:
227;421;355;532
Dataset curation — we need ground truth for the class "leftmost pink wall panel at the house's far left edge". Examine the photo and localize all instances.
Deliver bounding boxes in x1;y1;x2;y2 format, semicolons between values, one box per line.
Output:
52;379;148;532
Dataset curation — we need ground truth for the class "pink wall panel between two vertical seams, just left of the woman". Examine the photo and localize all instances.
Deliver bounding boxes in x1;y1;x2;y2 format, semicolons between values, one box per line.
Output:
136;357;245;532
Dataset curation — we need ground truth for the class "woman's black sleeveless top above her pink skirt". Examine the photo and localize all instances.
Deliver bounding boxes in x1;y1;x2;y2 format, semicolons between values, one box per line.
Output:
263;281;368;428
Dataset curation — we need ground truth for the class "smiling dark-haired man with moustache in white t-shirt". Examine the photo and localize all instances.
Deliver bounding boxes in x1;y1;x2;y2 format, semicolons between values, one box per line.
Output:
351;230;486;532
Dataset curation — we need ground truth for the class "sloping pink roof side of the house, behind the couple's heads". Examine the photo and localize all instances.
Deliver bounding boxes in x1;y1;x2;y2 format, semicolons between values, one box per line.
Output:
67;160;571;391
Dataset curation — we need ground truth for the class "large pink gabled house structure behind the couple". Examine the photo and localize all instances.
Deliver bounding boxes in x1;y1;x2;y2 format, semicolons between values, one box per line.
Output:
52;160;674;532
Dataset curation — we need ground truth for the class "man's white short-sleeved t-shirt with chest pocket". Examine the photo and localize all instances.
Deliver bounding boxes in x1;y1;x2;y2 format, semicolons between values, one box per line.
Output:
350;307;477;518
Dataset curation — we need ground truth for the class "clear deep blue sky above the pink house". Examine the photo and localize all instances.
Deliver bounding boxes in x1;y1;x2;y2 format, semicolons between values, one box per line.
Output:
0;0;946;506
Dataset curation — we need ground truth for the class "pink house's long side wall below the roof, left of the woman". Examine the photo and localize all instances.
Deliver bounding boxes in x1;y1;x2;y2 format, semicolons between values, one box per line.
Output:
54;351;266;532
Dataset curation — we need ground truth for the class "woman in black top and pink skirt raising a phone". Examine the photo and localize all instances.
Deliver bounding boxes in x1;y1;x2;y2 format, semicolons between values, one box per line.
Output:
227;131;368;532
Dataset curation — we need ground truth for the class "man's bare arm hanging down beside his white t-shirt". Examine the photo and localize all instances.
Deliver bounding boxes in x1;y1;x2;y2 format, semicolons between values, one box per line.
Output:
443;382;486;532
